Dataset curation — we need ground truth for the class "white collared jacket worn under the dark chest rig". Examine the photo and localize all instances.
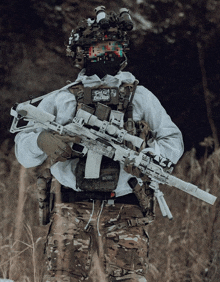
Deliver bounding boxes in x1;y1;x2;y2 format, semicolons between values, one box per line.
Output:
15;70;183;196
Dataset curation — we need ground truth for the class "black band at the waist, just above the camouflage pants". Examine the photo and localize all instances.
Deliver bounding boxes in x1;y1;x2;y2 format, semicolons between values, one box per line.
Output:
61;186;139;205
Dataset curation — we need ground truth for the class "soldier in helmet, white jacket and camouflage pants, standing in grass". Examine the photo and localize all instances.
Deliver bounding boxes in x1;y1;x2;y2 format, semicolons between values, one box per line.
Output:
15;6;183;282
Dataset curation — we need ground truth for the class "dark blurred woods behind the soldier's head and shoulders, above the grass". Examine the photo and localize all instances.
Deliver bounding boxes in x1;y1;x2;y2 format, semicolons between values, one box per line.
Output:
0;0;220;154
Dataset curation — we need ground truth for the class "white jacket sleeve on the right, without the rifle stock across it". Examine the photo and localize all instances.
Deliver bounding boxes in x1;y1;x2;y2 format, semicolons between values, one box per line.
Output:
134;86;184;164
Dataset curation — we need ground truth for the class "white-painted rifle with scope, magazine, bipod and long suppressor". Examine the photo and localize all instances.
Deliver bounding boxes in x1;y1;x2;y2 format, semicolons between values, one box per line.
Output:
10;98;216;219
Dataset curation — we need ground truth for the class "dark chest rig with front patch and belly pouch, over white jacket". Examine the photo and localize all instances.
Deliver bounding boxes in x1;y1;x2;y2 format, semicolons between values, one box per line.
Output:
69;80;149;192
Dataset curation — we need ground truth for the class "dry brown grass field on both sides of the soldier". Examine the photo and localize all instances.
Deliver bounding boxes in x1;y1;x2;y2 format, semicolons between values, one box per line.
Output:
0;140;220;282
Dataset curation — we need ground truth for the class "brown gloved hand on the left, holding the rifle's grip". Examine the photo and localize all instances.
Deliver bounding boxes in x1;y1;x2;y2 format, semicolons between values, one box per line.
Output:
37;131;81;162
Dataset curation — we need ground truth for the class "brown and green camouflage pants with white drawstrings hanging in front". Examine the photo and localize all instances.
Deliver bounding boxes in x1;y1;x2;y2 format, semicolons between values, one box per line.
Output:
43;201;151;282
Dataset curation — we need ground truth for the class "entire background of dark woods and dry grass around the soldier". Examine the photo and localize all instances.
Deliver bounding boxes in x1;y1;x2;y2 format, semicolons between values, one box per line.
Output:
0;0;220;282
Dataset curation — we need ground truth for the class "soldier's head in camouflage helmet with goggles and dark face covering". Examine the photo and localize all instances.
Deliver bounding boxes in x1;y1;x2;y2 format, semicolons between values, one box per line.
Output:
66;6;133;78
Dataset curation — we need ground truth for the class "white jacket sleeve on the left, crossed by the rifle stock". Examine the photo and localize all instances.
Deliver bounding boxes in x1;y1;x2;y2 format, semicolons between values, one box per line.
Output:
15;90;76;168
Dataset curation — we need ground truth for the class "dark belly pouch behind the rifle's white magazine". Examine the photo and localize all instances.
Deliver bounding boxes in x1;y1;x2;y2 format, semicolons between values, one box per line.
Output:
75;156;120;192
